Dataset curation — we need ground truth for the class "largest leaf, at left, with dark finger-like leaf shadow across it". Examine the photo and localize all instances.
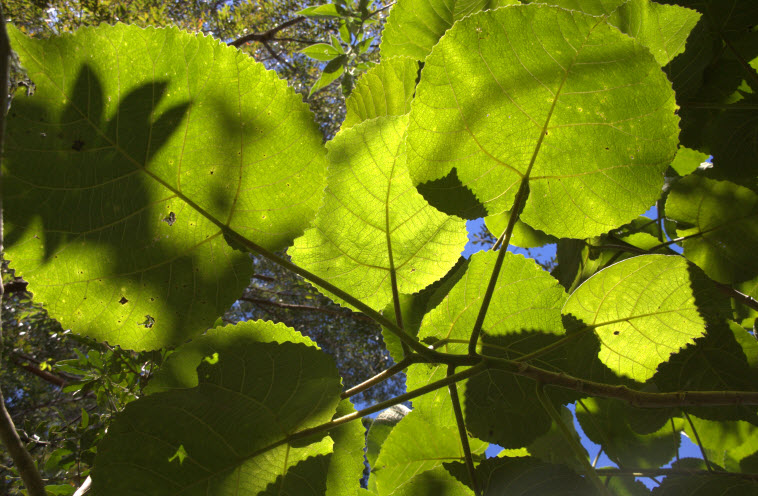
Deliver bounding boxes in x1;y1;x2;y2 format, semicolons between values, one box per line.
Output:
3;25;325;349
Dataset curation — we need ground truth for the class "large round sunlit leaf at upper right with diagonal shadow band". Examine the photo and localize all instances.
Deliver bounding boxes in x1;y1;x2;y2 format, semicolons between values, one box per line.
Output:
408;4;679;238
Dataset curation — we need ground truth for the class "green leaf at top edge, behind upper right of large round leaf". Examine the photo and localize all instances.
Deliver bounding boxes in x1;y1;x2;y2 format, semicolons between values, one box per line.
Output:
524;0;700;66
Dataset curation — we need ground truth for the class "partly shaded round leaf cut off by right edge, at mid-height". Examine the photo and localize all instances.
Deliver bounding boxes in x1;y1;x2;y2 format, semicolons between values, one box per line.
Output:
666;176;758;284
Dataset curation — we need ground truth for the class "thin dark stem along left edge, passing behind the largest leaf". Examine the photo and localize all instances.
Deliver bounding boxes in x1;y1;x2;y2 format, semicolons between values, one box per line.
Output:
0;7;46;496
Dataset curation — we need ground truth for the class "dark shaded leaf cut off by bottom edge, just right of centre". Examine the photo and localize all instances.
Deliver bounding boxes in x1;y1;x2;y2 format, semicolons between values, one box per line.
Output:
476;457;595;496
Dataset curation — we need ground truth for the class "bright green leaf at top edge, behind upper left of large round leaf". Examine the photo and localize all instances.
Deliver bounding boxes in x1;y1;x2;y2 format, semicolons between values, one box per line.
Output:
379;0;518;60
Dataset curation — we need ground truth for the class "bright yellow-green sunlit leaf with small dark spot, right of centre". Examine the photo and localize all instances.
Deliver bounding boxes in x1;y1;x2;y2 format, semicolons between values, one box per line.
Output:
563;255;716;382
